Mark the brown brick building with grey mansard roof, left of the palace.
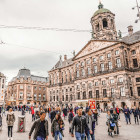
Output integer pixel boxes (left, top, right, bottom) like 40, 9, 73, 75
6, 68, 48, 105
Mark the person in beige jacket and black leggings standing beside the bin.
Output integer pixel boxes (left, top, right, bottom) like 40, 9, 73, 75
6, 108, 15, 140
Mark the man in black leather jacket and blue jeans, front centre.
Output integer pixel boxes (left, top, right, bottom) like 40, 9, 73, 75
71, 108, 89, 140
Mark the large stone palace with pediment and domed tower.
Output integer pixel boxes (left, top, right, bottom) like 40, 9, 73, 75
48, 3, 140, 109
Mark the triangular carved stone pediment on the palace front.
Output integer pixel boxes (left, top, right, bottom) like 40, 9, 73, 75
75, 40, 117, 59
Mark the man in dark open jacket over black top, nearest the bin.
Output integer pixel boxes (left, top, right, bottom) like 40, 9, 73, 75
29, 112, 49, 140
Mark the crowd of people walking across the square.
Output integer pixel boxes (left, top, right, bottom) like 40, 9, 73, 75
0, 104, 140, 140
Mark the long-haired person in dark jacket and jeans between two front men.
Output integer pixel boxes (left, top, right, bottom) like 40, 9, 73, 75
51, 112, 64, 140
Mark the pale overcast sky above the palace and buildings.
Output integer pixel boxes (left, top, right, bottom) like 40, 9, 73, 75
0, 0, 140, 81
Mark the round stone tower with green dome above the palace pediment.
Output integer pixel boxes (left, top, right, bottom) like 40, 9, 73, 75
91, 2, 117, 40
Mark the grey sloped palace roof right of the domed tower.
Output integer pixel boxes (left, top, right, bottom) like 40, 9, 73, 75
122, 31, 140, 44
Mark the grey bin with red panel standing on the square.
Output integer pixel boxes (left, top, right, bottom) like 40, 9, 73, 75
17, 116, 26, 132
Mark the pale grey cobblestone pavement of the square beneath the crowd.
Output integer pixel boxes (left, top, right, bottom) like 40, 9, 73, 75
0, 112, 140, 140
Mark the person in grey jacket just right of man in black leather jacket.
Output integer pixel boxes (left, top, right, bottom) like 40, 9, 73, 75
85, 109, 96, 140
